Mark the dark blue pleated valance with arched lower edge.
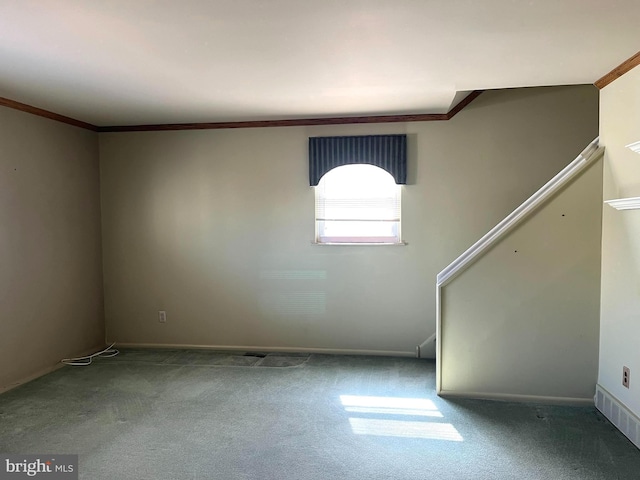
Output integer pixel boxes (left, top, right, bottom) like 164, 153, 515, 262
309, 135, 407, 186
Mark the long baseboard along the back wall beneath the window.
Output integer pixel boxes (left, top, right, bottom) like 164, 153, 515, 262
107, 340, 415, 357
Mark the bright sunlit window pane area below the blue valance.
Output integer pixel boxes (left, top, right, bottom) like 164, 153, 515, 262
315, 164, 402, 244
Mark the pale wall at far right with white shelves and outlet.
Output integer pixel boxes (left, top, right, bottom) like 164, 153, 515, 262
598, 63, 640, 416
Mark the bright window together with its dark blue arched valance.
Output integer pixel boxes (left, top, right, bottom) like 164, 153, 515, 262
309, 135, 407, 244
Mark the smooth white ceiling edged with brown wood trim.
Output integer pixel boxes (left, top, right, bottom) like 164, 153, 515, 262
0, 0, 640, 126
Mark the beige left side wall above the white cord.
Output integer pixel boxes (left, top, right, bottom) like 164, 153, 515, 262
0, 107, 104, 390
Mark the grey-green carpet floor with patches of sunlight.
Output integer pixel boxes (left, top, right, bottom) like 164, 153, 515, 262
0, 350, 640, 480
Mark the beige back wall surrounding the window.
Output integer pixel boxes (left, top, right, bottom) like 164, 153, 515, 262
100, 86, 598, 355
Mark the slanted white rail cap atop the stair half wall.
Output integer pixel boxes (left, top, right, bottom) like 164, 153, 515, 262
437, 137, 604, 286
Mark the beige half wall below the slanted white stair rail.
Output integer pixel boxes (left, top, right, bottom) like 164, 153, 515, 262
441, 160, 602, 402
